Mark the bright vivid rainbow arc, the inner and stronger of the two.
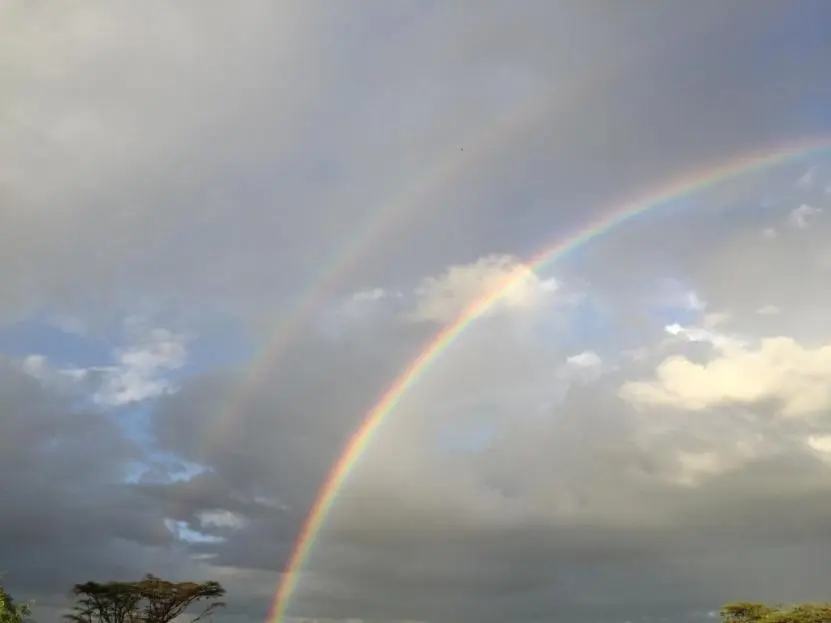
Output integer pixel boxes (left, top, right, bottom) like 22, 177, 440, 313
268, 138, 831, 622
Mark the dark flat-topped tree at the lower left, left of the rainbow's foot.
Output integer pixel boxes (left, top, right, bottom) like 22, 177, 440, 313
66, 574, 225, 623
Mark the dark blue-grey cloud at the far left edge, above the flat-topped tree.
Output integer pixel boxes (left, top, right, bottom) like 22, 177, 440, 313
0, 359, 198, 603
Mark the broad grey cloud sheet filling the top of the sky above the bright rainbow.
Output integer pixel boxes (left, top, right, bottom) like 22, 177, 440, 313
2, 2, 827, 322
